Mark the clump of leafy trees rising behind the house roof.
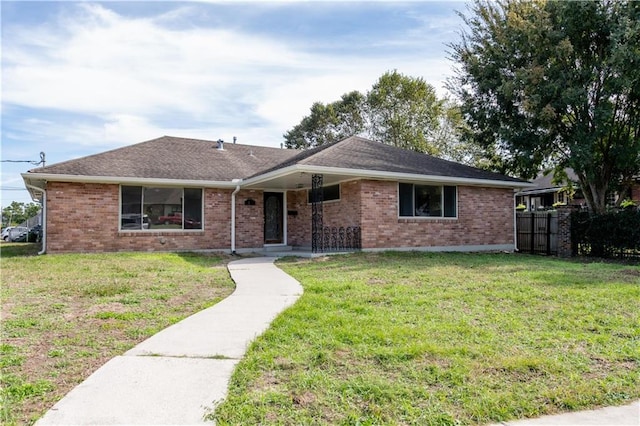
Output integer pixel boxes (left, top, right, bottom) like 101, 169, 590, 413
284, 71, 479, 160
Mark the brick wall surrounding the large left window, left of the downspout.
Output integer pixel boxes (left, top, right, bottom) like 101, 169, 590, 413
46, 182, 235, 253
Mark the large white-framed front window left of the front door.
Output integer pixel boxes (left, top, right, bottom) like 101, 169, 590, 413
120, 186, 202, 231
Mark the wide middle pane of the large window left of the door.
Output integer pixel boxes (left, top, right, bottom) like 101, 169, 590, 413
143, 188, 182, 229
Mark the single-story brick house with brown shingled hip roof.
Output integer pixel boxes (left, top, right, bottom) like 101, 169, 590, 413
22, 136, 530, 253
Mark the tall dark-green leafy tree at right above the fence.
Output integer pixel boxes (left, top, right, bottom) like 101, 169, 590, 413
448, 0, 640, 212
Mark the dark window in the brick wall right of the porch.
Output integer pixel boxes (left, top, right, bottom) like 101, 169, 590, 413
398, 183, 457, 217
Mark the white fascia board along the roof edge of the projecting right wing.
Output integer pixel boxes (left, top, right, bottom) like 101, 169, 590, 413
243, 164, 535, 188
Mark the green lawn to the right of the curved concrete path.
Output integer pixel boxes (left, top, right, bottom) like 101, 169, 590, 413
213, 253, 640, 425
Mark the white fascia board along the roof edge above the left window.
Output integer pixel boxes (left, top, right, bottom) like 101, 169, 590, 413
22, 173, 238, 188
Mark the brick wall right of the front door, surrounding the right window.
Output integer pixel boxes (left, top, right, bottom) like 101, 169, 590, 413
287, 180, 514, 249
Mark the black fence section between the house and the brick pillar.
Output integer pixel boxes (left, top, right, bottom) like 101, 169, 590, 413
516, 211, 558, 255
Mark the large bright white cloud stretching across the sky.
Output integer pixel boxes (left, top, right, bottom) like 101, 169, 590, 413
3, 3, 458, 150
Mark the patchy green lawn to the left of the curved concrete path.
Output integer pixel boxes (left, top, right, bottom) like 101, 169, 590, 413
0, 243, 234, 425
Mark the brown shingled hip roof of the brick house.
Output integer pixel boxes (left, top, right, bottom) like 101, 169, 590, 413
22, 136, 530, 200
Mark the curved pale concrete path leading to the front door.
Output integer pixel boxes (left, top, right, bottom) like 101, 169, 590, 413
36, 257, 302, 425
